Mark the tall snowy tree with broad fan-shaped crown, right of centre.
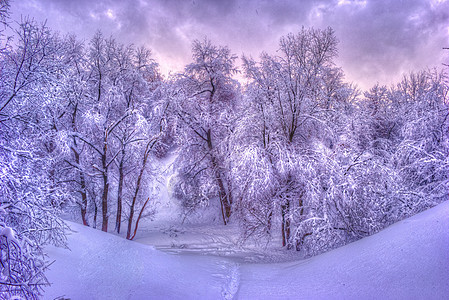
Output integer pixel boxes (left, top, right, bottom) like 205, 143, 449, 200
236, 28, 353, 248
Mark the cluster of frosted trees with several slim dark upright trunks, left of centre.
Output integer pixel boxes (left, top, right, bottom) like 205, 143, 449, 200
62, 32, 160, 232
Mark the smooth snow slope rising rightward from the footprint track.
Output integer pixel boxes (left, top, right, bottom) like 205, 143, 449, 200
237, 202, 449, 299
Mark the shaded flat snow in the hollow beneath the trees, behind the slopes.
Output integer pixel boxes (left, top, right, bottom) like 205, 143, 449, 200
128, 153, 302, 262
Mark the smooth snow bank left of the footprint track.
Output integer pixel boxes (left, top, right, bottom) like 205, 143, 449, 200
44, 223, 238, 300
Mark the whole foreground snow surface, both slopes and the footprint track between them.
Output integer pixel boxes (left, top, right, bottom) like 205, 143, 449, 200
44, 202, 449, 299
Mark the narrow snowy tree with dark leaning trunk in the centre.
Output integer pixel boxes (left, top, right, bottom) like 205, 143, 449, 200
171, 40, 238, 224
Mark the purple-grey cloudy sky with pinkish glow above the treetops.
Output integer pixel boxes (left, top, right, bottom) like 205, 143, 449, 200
11, 0, 449, 89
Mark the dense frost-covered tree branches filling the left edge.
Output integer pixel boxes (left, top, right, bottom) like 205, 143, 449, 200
0, 15, 71, 299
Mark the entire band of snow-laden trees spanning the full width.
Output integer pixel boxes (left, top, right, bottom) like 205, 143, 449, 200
0, 0, 449, 299
